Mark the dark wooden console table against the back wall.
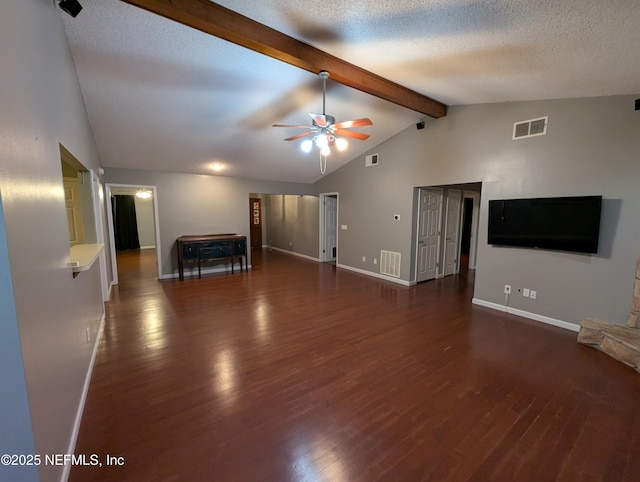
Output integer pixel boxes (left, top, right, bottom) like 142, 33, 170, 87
177, 234, 247, 280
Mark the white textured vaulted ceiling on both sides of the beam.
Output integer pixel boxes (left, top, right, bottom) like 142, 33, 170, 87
61, 0, 640, 182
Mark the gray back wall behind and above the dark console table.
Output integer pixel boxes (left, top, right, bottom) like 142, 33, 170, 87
104, 168, 313, 277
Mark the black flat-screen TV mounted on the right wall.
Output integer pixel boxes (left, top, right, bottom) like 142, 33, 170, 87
488, 196, 602, 253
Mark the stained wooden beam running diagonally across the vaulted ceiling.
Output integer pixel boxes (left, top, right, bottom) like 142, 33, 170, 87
122, 0, 447, 118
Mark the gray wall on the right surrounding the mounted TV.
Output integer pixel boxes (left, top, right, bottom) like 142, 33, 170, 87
314, 96, 640, 324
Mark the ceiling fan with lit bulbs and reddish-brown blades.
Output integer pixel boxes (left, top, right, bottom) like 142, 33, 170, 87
272, 70, 373, 174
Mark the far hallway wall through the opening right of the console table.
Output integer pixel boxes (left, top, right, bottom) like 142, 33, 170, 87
263, 195, 319, 259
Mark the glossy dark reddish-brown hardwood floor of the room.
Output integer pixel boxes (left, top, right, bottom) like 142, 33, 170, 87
70, 251, 640, 482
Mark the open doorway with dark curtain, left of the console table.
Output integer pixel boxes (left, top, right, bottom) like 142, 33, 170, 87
106, 184, 162, 285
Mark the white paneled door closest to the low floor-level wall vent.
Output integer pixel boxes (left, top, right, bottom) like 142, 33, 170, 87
416, 189, 442, 283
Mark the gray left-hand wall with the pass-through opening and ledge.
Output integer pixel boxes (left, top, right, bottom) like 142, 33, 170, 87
0, 0, 103, 481
